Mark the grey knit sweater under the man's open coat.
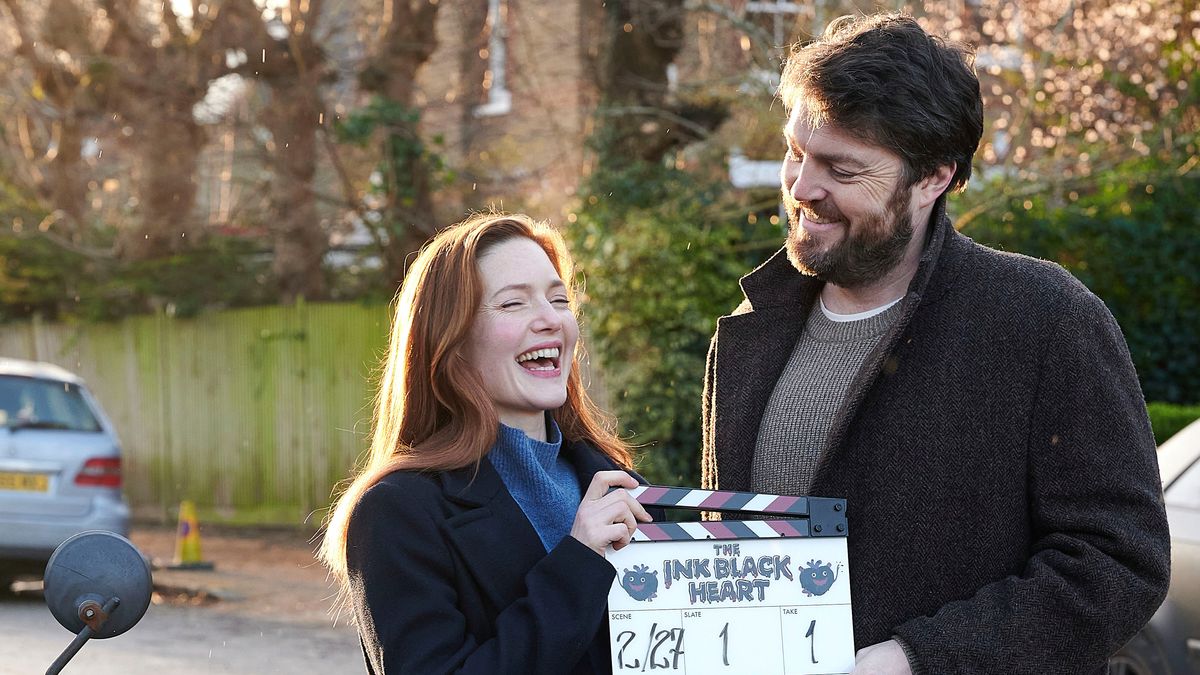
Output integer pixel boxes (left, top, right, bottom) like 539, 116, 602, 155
750, 304, 900, 495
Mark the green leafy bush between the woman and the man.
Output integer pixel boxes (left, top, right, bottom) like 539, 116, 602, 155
568, 162, 782, 485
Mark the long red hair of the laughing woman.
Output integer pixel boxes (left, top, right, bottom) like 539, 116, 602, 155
318, 214, 632, 591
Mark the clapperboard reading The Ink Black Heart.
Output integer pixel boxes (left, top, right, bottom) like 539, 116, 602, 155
607, 485, 854, 675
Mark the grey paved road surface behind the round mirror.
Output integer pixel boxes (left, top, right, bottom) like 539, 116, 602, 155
0, 586, 364, 675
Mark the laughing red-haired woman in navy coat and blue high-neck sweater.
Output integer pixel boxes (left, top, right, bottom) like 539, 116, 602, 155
320, 214, 650, 675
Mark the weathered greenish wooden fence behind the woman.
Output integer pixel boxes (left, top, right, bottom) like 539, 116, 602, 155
0, 304, 389, 525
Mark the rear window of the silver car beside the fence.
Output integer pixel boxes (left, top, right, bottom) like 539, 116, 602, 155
0, 376, 100, 431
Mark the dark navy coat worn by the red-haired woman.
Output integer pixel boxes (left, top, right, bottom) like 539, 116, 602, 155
347, 443, 648, 675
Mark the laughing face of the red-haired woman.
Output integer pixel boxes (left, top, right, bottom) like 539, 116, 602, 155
466, 237, 580, 438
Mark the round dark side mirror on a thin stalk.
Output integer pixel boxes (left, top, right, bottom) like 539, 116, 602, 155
43, 531, 154, 675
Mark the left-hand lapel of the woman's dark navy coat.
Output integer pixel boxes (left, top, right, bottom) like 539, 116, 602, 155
442, 458, 546, 611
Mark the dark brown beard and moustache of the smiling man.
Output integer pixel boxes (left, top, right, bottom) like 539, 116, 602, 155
784, 184, 912, 288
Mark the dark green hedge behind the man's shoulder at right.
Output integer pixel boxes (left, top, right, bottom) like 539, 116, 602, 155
962, 160, 1200, 405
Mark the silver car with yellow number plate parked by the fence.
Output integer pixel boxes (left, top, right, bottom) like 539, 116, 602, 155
0, 358, 130, 581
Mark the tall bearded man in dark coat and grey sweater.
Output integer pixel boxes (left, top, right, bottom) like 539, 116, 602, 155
703, 14, 1170, 675
